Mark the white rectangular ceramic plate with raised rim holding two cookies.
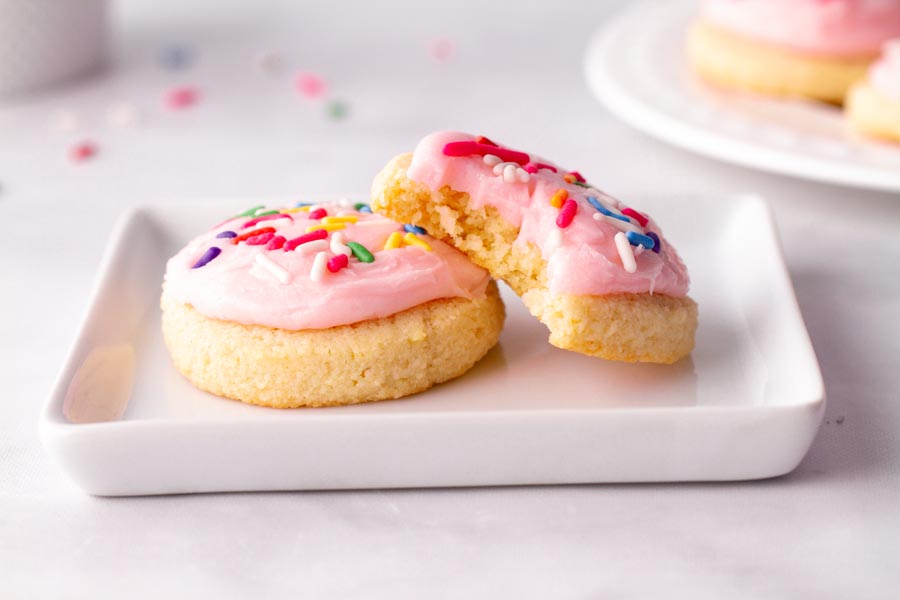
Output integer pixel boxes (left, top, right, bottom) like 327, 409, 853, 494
41, 196, 824, 495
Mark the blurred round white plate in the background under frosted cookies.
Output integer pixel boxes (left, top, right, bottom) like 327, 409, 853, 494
585, 1, 900, 191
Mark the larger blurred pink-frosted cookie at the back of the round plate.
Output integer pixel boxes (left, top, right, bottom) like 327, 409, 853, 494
687, 0, 900, 104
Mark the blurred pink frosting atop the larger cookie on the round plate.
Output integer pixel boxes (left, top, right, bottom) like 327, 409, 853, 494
702, 0, 900, 57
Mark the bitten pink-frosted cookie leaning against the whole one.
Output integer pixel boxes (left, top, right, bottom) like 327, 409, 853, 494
372, 132, 697, 363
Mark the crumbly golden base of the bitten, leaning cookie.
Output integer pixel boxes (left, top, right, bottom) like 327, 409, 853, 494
372, 154, 697, 364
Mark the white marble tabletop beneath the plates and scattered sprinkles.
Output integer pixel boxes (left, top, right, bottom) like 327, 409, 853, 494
0, 0, 900, 599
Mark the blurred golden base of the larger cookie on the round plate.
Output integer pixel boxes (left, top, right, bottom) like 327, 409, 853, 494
687, 20, 875, 104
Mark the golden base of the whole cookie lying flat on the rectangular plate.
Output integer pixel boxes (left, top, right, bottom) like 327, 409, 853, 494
161, 281, 505, 408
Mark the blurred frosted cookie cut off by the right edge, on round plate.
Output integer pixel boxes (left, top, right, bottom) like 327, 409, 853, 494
847, 39, 900, 142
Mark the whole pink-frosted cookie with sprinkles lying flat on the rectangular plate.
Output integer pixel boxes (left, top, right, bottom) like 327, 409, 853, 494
161, 204, 504, 408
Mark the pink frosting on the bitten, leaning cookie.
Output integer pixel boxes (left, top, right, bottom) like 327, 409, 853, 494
407, 132, 689, 297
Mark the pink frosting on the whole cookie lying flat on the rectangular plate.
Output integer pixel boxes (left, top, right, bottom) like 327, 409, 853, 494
158, 205, 490, 330
